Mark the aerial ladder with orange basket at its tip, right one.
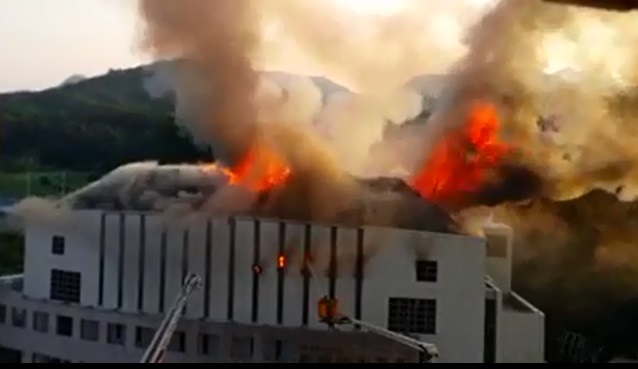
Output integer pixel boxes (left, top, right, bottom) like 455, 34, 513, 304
317, 296, 439, 363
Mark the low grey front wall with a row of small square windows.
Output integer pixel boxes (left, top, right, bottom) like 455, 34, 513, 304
0, 286, 417, 363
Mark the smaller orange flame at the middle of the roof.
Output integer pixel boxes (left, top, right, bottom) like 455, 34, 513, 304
203, 146, 291, 192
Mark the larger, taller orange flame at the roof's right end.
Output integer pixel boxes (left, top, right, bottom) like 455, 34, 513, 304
412, 103, 510, 208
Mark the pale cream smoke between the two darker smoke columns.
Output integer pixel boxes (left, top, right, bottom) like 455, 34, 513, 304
253, 0, 500, 176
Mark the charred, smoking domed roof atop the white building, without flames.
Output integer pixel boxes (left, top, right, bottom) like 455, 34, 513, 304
60, 162, 457, 233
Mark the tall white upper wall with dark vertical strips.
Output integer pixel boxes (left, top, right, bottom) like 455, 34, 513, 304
18, 211, 486, 362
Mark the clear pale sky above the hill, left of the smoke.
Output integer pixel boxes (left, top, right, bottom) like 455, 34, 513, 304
0, 0, 144, 92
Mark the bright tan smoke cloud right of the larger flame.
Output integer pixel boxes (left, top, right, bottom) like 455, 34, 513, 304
442, 1, 638, 201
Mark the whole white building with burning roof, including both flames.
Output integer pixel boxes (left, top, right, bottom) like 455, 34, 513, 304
0, 77, 544, 362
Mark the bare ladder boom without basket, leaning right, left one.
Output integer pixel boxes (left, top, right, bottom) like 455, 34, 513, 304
140, 274, 202, 363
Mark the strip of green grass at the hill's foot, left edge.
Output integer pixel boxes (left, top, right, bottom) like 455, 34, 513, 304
0, 172, 96, 198
